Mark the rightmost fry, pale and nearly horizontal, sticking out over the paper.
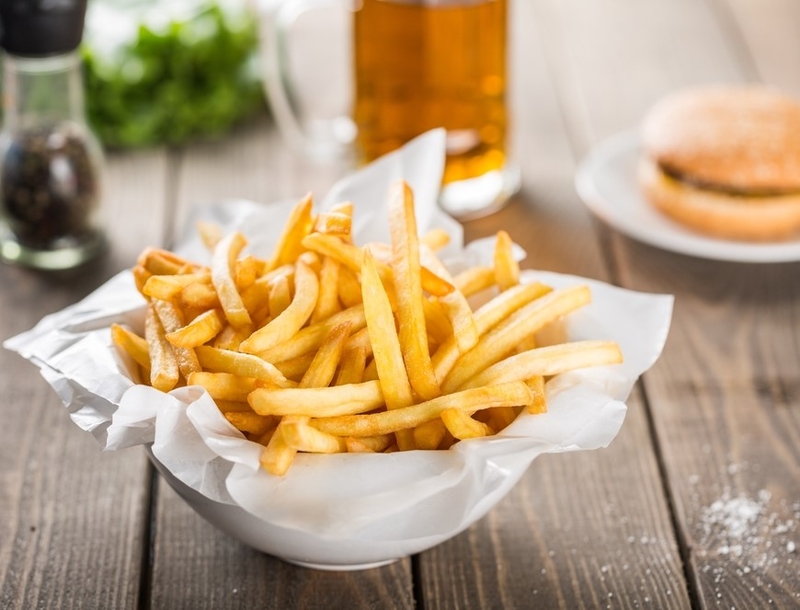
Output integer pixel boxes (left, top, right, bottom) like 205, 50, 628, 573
459, 340, 622, 388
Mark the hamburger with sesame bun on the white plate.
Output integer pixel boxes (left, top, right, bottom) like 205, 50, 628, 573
639, 85, 800, 242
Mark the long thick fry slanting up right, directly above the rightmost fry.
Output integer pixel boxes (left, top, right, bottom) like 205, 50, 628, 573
442, 285, 591, 392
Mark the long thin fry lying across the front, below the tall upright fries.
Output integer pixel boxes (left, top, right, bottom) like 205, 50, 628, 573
311, 381, 531, 437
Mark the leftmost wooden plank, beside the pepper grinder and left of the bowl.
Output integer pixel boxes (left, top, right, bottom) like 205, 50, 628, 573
0, 146, 170, 608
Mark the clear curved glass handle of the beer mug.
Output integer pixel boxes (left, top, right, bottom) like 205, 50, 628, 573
260, 0, 355, 162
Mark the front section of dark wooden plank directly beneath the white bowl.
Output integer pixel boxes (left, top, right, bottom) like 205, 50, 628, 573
151, 479, 414, 610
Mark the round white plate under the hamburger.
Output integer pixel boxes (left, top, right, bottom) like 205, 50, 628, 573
575, 131, 800, 263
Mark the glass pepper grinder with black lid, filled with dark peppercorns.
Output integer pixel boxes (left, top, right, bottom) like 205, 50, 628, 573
0, 0, 104, 270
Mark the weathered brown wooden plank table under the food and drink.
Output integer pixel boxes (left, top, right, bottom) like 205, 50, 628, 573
0, 0, 800, 610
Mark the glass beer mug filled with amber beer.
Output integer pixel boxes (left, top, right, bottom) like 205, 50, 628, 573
261, 0, 520, 219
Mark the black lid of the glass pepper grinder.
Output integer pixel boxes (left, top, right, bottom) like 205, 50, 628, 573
0, 0, 87, 57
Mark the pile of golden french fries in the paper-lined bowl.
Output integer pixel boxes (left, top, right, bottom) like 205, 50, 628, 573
112, 182, 622, 475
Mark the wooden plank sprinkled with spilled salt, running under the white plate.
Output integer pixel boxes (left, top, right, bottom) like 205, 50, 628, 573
536, 2, 800, 607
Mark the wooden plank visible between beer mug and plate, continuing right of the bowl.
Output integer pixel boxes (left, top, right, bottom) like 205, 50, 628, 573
419, 2, 689, 609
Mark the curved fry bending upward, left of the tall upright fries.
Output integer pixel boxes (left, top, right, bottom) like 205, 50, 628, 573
239, 261, 319, 354
